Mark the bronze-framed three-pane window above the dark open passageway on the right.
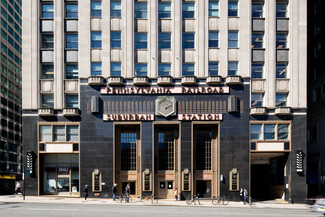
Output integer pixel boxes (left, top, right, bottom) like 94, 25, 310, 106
251, 123, 290, 141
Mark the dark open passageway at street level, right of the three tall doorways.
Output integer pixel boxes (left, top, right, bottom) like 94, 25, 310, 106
251, 153, 287, 200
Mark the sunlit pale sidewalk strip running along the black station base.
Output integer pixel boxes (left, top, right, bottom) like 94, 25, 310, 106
0, 195, 310, 209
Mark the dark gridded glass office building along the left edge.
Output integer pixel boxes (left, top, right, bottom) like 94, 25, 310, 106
0, 0, 22, 194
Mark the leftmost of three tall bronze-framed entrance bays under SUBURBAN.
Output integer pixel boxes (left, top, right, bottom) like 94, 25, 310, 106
115, 125, 141, 197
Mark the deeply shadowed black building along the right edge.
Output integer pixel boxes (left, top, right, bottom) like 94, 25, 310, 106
307, 0, 325, 197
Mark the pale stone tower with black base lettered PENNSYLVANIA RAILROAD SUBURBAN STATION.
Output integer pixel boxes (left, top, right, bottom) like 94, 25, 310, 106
23, 0, 307, 201
